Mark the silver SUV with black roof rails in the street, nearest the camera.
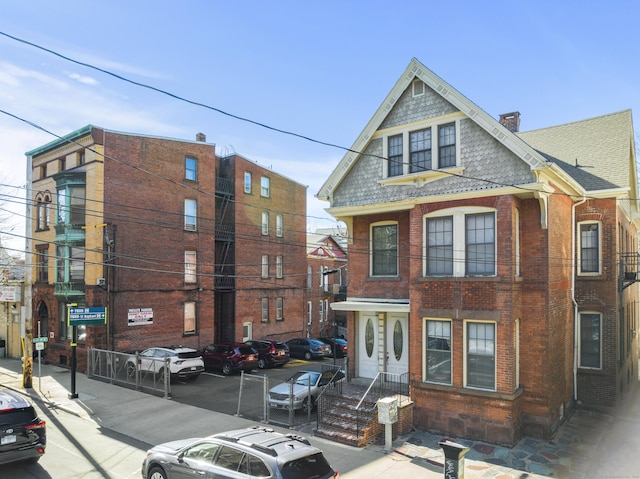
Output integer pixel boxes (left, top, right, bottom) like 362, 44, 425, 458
142, 426, 340, 479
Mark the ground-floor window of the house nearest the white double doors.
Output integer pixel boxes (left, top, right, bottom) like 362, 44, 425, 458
423, 319, 452, 385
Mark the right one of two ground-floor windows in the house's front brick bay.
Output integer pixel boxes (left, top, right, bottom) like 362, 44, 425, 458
464, 321, 496, 391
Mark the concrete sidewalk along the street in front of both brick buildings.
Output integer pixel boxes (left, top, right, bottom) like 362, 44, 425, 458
0, 358, 640, 479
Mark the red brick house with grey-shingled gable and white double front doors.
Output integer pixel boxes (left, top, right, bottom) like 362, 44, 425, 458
318, 59, 639, 445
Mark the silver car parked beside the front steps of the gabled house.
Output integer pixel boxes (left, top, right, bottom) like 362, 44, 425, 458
269, 370, 344, 409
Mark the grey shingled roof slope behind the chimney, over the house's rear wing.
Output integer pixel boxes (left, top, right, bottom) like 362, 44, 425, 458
518, 110, 637, 198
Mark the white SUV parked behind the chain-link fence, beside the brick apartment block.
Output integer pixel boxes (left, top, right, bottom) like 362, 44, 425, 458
127, 346, 204, 380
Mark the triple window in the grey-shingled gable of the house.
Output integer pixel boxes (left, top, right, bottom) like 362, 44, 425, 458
382, 119, 460, 178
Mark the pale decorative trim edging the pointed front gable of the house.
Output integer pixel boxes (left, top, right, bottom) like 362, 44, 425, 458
316, 58, 547, 200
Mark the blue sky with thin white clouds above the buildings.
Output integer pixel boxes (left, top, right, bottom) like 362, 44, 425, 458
0, 0, 640, 255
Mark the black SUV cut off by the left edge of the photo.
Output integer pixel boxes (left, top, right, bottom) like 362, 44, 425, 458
0, 389, 47, 464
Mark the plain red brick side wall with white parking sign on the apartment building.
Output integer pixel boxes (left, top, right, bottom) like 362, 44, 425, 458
102, 132, 215, 351
